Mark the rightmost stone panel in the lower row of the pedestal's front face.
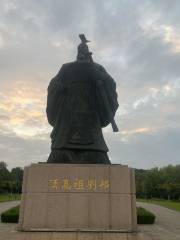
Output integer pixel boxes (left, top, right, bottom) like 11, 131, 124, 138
110, 194, 132, 230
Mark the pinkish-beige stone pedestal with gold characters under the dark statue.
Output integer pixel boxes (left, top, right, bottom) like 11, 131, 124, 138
19, 163, 137, 232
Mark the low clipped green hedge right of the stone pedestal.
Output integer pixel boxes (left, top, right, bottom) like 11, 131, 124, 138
137, 207, 156, 224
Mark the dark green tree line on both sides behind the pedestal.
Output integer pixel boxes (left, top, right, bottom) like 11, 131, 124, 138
0, 162, 180, 200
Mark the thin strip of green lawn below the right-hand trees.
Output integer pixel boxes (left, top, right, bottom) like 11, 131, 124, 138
137, 199, 180, 212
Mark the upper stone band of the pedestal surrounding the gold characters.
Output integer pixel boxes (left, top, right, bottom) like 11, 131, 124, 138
23, 164, 135, 193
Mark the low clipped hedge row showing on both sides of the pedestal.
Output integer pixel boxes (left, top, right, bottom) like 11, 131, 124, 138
1, 206, 155, 224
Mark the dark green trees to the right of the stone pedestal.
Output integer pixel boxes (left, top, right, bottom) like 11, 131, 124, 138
135, 165, 180, 200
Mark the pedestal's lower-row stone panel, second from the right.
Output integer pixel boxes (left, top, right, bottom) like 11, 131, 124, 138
89, 194, 109, 229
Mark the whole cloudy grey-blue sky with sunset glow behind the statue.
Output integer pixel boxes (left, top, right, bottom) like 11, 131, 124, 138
0, 0, 180, 168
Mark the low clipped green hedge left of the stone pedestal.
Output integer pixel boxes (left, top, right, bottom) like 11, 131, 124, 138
1, 206, 19, 223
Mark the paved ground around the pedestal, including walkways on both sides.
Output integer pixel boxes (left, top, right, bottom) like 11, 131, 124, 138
0, 201, 180, 240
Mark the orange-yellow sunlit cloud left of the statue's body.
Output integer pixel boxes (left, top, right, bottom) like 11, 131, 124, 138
0, 83, 50, 138
